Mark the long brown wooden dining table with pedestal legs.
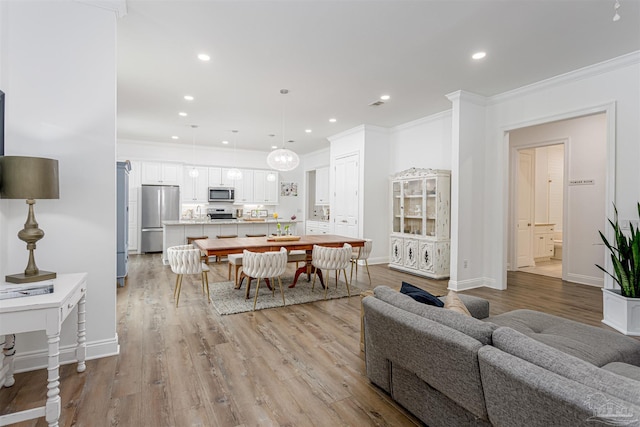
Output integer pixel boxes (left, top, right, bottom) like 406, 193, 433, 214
193, 234, 365, 288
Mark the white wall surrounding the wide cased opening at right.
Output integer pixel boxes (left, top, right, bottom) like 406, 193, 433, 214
484, 52, 640, 287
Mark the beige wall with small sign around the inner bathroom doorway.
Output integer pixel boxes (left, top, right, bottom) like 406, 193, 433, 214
509, 114, 607, 286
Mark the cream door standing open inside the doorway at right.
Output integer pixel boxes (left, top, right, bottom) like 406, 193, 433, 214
516, 150, 533, 268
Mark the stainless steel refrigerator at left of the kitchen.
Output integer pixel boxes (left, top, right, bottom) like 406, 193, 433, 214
140, 185, 180, 253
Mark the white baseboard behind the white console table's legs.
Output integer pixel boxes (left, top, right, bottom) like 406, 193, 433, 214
13, 334, 120, 373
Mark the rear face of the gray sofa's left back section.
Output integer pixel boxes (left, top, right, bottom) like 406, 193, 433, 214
362, 296, 486, 419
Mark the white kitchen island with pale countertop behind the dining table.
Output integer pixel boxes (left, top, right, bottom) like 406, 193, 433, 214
162, 219, 301, 264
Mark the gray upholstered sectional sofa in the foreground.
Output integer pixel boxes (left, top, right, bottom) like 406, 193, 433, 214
362, 286, 640, 427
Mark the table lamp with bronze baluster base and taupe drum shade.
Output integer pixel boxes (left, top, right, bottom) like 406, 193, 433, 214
0, 156, 59, 283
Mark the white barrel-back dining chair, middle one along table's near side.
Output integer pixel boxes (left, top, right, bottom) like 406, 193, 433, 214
242, 248, 287, 311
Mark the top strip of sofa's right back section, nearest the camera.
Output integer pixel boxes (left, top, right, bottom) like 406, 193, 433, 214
493, 327, 640, 405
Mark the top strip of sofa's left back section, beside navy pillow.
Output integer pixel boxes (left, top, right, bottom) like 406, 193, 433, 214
373, 286, 497, 344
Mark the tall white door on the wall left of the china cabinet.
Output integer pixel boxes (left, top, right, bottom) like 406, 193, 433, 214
331, 154, 360, 237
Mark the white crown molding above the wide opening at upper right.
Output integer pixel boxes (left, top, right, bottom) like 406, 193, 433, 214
487, 50, 640, 105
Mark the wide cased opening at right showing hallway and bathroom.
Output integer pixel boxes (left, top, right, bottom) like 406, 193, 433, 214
508, 110, 611, 286
